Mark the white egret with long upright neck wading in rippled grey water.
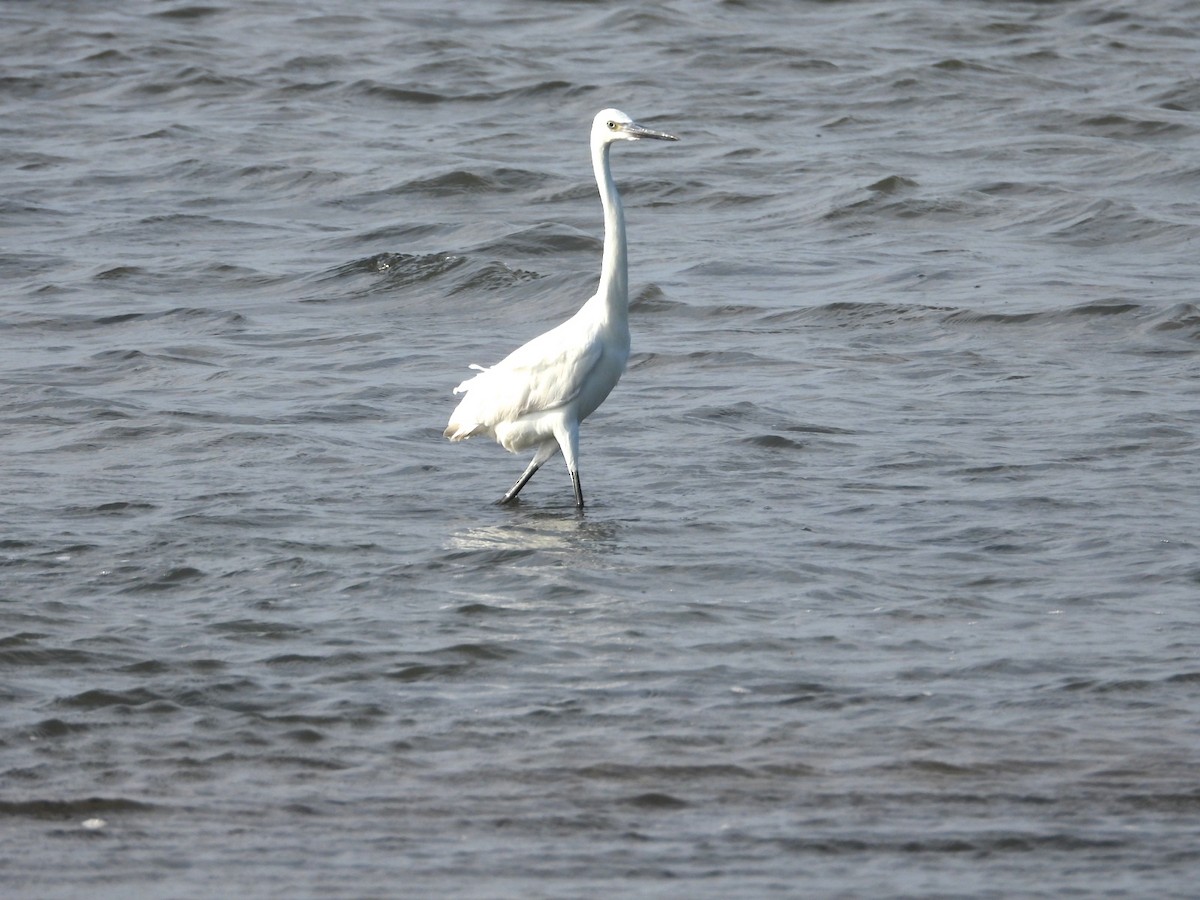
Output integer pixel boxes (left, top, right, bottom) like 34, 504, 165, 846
445, 109, 678, 508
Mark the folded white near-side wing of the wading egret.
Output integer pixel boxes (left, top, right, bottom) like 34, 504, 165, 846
445, 323, 604, 440
